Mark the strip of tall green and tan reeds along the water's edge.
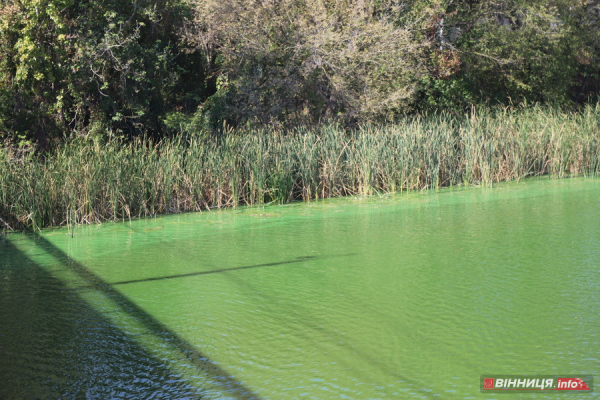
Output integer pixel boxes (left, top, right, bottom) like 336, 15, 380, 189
0, 106, 600, 229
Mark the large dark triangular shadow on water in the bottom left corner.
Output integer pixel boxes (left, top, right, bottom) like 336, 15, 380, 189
0, 238, 202, 400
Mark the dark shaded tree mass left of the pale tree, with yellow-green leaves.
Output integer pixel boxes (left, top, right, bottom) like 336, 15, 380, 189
0, 0, 204, 146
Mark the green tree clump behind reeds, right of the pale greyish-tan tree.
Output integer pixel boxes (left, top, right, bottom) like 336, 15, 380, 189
413, 0, 600, 107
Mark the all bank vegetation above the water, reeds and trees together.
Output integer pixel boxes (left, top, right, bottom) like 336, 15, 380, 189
0, 0, 600, 231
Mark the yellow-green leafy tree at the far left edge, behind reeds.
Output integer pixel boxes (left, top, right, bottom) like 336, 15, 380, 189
0, 0, 72, 142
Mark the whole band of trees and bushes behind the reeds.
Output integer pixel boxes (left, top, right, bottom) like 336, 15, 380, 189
0, 0, 600, 144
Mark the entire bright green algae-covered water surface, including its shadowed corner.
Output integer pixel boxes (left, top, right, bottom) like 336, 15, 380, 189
0, 178, 600, 399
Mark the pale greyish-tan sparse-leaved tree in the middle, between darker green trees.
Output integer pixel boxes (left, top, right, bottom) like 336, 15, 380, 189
185, 0, 425, 126
